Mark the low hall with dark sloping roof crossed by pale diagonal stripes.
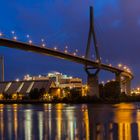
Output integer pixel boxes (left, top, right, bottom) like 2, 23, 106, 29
0, 80, 55, 99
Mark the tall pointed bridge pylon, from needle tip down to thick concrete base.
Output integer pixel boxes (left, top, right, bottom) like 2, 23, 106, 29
85, 7, 101, 97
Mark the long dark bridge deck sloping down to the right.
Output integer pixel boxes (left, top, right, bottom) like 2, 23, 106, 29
0, 38, 133, 79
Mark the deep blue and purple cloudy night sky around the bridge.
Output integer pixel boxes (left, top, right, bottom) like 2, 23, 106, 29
0, 0, 140, 87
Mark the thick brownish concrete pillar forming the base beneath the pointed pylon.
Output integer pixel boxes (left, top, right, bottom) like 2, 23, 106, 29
87, 74, 99, 97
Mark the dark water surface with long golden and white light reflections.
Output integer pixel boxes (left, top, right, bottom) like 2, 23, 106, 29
0, 103, 140, 140
